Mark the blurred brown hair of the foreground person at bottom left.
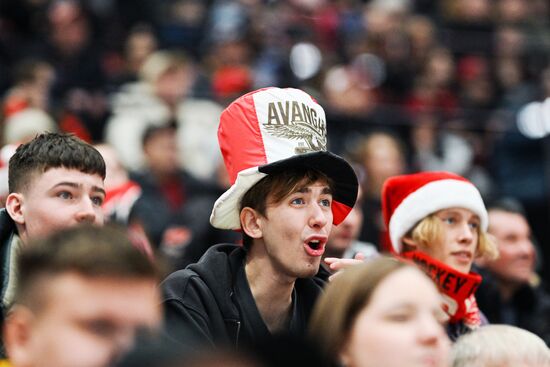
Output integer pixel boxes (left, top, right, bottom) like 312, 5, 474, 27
15, 224, 163, 309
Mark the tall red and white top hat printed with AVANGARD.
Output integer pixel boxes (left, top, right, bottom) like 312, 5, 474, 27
210, 88, 358, 229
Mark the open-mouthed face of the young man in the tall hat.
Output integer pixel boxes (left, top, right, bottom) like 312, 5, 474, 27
253, 181, 332, 278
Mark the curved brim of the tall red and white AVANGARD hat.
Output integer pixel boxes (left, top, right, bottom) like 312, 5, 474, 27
210, 151, 358, 229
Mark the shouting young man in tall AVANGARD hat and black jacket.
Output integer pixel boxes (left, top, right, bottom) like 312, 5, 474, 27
162, 88, 357, 346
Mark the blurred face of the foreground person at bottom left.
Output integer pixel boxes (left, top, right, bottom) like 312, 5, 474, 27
8, 273, 161, 367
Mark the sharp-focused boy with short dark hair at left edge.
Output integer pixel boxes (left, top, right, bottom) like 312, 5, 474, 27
0, 133, 105, 324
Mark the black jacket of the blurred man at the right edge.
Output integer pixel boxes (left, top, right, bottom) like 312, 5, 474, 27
476, 271, 550, 346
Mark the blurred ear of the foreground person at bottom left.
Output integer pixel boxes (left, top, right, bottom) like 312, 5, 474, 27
3, 306, 34, 366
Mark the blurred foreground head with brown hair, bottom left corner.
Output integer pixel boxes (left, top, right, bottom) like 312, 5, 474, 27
4, 226, 161, 367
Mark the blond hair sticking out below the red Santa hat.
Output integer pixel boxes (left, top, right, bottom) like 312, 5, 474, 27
403, 213, 498, 260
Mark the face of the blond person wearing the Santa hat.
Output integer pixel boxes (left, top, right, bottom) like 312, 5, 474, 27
418, 208, 480, 273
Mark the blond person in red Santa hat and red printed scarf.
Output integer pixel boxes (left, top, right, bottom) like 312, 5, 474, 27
382, 172, 498, 339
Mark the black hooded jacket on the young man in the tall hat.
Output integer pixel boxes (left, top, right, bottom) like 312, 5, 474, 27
161, 244, 324, 347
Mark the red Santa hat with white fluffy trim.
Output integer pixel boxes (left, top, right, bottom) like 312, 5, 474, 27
382, 172, 488, 253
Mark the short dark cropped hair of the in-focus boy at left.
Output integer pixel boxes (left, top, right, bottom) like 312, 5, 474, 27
8, 133, 105, 193
